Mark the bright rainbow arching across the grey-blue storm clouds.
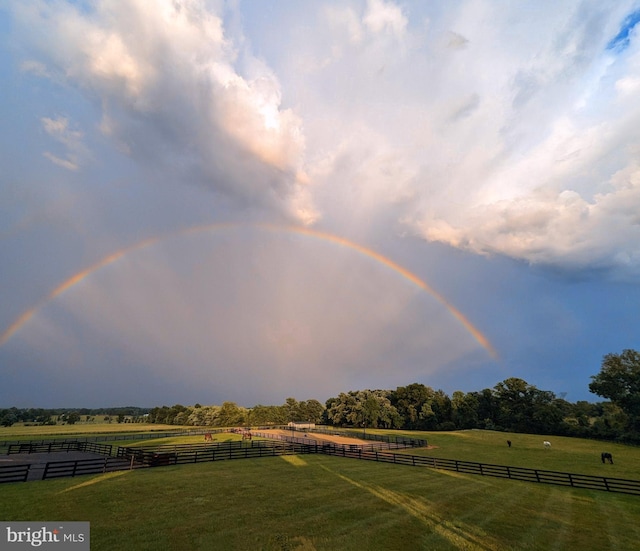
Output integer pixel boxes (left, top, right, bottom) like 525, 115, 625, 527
0, 223, 498, 358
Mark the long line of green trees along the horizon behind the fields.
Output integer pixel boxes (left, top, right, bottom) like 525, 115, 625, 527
5, 349, 640, 443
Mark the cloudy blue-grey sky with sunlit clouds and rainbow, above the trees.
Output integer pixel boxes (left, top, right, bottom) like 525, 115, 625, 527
0, 0, 640, 407
